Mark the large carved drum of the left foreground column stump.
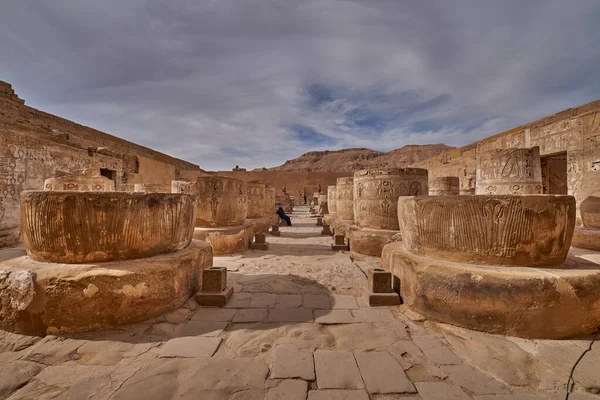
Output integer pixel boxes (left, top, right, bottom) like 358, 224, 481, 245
21, 191, 194, 264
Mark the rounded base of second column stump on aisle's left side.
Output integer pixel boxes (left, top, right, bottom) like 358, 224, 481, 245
194, 223, 254, 255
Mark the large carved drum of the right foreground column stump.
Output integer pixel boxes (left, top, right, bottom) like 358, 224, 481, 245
398, 195, 575, 267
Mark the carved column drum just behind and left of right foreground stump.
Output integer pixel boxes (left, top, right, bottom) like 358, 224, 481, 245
354, 168, 428, 230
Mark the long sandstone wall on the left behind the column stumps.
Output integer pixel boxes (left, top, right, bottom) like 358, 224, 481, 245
0, 81, 200, 247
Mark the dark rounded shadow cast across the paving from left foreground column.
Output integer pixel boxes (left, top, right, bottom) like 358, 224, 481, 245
61, 273, 340, 344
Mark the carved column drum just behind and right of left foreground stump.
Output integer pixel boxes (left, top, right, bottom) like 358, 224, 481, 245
171, 176, 248, 228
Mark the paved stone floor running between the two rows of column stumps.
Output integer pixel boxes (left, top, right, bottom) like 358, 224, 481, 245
0, 207, 600, 400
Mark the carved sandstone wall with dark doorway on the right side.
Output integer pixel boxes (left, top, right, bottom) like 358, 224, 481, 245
413, 100, 600, 224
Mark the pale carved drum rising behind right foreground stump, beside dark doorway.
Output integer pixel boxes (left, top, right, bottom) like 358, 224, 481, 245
475, 147, 543, 194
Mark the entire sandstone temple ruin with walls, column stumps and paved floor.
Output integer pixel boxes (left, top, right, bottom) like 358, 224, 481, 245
0, 82, 600, 400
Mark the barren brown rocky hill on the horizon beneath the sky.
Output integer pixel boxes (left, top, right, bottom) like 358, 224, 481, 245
269, 144, 452, 172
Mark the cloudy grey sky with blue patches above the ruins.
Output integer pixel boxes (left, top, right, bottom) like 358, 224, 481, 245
0, 0, 600, 170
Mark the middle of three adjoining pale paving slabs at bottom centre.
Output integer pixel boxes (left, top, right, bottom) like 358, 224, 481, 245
314, 350, 365, 389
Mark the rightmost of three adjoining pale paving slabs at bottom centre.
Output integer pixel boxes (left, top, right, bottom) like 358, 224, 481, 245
354, 351, 417, 394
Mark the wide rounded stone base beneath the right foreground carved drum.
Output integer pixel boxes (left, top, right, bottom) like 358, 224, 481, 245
381, 242, 600, 339
